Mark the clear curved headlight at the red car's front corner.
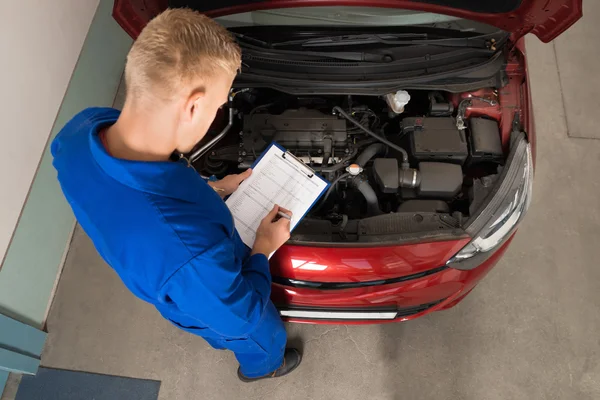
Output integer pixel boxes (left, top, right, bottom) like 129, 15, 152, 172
446, 134, 533, 270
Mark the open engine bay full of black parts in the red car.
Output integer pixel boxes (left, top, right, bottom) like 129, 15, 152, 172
194, 89, 506, 244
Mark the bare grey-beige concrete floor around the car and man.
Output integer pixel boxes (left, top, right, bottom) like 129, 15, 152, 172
8, 10, 600, 400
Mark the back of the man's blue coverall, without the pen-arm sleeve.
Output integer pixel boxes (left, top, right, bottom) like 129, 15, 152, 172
52, 108, 247, 325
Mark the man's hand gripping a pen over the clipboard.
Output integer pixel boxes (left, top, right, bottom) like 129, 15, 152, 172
252, 205, 292, 257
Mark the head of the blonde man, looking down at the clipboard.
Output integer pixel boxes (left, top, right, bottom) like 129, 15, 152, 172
125, 9, 241, 153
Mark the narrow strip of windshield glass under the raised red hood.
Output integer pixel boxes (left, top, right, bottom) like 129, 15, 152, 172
216, 6, 498, 33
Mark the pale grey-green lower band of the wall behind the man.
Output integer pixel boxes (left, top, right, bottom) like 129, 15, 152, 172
0, 0, 132, 327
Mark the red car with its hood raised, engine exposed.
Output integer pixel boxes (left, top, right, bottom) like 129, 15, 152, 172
114, 0, 582, 324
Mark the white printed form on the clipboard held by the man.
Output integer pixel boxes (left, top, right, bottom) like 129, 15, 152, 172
225, 143, 329, 248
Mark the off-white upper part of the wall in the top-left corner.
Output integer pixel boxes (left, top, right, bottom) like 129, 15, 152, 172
0, 0, 98, 260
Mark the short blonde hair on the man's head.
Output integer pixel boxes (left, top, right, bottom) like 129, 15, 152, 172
125, 8, 241, 99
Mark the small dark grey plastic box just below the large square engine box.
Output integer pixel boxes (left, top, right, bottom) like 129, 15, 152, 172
418, 162, 463, 199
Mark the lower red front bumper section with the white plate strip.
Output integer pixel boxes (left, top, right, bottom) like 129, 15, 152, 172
271, 237, 512, 324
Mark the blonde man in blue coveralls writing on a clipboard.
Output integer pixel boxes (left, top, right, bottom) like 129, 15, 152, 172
52, 9, 301, 382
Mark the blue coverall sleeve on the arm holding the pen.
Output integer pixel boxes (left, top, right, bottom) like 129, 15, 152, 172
164, 238, 271, 338
